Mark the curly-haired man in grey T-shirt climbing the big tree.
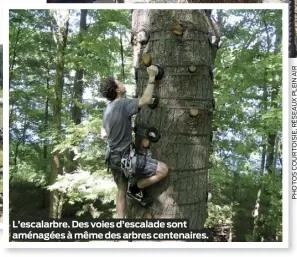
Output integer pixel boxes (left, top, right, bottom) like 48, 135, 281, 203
100, 65, 168, 218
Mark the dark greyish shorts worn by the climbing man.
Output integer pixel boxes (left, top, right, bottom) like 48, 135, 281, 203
111, 153, 158, 184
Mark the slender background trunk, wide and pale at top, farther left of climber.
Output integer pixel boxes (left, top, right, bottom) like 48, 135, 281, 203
49, 10, 70, 218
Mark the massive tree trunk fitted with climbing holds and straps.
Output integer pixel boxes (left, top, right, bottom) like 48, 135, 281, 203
128, 10, 217, 229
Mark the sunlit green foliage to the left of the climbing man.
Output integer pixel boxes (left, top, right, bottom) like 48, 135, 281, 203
9, 10, 132, 217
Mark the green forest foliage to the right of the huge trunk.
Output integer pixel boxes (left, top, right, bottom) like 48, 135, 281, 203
206, 10, 282, 241
